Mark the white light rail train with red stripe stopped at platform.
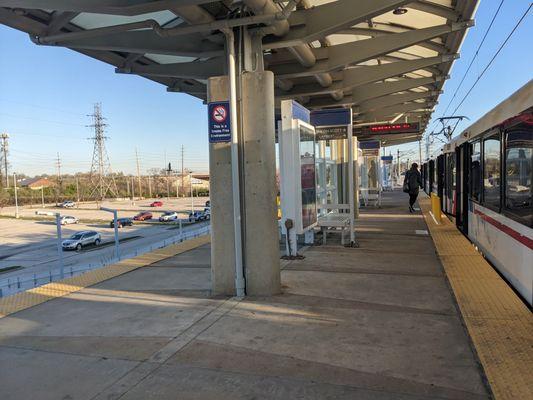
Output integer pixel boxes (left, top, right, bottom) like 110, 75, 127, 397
422, 81, 533, 307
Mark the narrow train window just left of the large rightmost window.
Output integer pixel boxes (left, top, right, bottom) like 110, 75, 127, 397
483, 134, 501, 211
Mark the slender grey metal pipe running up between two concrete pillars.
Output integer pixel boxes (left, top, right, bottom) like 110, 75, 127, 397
224, 29, 245, 297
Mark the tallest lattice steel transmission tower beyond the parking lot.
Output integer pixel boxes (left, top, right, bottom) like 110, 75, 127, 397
89, 103, 118, 200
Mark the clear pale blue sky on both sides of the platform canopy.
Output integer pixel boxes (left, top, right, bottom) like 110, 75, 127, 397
0, 0, 533, 175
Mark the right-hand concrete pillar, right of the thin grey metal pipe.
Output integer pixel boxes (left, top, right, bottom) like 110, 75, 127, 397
242, 71, 281, 296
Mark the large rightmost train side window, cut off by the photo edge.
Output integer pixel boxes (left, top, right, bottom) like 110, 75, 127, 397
505, 124, 533, 227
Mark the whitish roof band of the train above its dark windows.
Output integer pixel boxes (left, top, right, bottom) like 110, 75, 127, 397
442, 80, 533, 153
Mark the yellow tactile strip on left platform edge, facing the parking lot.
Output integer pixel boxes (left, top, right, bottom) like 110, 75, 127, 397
0, 235, 210, 318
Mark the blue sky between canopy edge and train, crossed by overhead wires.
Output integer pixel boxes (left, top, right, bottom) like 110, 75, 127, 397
386, 0, 533, 161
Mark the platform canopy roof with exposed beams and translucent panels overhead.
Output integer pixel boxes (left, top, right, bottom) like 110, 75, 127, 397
0, 0, 479, 144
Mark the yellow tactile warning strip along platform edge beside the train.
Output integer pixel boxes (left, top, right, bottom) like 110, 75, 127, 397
420, 199, 533, 400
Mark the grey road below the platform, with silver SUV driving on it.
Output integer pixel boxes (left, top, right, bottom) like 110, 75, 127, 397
0, 219, 209, 295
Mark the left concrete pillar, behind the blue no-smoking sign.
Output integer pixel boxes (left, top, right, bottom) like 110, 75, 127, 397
207, 76, 235, 295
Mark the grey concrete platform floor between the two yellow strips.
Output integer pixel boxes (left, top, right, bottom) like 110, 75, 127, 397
0, 193, 490, 400
